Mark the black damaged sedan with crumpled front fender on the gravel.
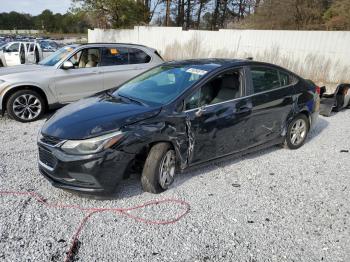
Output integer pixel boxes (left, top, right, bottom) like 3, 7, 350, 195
38, 59, 319, 194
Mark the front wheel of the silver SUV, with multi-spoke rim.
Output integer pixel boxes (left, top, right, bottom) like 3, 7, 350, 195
6, 90, 46, 123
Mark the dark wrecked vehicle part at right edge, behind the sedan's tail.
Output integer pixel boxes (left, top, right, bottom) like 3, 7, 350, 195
320, 84, 350, 116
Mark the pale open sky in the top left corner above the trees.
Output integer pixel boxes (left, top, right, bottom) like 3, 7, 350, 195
0, 0, 71, 15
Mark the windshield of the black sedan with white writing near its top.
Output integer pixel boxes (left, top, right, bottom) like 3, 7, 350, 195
113, 64, 219, 105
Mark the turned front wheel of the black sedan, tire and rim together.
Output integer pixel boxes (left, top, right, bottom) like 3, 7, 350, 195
141, 143, 176, 194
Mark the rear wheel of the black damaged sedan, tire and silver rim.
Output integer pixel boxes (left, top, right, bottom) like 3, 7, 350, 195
284, 114, 310, 150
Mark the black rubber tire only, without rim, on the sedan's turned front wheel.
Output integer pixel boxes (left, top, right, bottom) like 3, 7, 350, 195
141, 143, 176, 194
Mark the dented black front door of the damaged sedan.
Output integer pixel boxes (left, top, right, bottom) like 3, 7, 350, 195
186, 98, 252, 164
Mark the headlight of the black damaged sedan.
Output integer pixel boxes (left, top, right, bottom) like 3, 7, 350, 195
61, 131, 123, 155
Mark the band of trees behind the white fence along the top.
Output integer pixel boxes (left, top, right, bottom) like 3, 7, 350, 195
0, 0, 350, 33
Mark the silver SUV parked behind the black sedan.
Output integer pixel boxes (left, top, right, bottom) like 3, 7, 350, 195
0, 44, 163, 122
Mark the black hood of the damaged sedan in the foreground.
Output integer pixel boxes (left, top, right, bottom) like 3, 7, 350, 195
41, 94, 161, 140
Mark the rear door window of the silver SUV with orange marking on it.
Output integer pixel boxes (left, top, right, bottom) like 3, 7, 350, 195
101, 47, 129, 66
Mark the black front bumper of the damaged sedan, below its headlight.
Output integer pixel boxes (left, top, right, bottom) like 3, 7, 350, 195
38, 143, 134, 194
